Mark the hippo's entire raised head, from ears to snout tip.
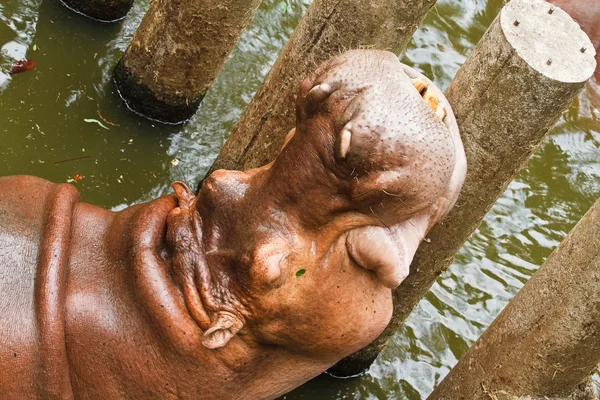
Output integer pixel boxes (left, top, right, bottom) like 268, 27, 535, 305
168, 50, 466, 367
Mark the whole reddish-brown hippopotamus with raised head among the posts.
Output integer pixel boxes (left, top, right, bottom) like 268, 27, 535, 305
0, 50, 466, 400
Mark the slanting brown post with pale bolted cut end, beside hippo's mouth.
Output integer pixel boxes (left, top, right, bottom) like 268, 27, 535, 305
332, 0, 595, 376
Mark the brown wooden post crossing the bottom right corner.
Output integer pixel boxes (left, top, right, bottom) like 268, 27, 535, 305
429, 200, 600, 400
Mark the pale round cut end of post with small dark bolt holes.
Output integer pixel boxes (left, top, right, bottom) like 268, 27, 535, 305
500, 0, 596, 83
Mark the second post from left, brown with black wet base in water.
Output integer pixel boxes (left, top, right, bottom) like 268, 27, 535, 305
114, 0, 261, 123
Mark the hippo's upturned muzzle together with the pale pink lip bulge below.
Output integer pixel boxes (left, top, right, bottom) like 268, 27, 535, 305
275, 50, 466, 288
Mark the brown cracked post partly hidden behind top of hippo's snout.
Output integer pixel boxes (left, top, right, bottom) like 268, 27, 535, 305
211, 0, 435, 170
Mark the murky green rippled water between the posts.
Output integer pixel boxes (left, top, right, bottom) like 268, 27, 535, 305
0, 0, 600, 400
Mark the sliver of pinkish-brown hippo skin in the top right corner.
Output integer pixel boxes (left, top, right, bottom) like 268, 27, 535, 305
548, 0, 600, 101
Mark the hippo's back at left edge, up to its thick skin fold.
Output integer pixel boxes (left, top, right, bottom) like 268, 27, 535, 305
0, 176, 79, 399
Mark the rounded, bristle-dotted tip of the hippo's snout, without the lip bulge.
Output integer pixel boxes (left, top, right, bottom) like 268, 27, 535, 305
297, 50, 462, 225
